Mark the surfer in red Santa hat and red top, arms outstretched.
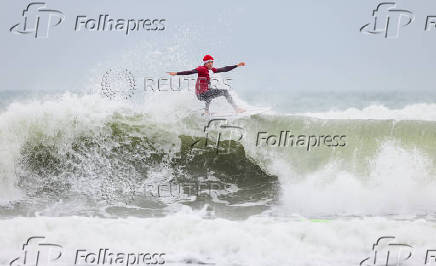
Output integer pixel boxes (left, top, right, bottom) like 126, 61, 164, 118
168, 55, 245, 114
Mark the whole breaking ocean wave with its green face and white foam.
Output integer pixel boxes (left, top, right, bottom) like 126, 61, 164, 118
0, 93, 436, 216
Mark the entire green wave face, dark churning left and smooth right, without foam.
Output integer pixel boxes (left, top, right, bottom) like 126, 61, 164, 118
10, 114, 436, 218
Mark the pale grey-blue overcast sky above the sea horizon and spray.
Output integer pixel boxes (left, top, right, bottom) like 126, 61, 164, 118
0, 0, 436, 95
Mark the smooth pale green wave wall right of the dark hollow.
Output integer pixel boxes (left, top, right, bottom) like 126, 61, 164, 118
238, 115, 436, 176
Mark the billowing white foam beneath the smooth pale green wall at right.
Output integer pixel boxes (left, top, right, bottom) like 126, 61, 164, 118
271, 142, 436, 216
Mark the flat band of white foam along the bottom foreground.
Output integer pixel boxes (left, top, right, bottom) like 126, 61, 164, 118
0, 212, 436, 266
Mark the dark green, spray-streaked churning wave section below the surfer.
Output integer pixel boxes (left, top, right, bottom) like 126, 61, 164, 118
17, 115, 277, 213
